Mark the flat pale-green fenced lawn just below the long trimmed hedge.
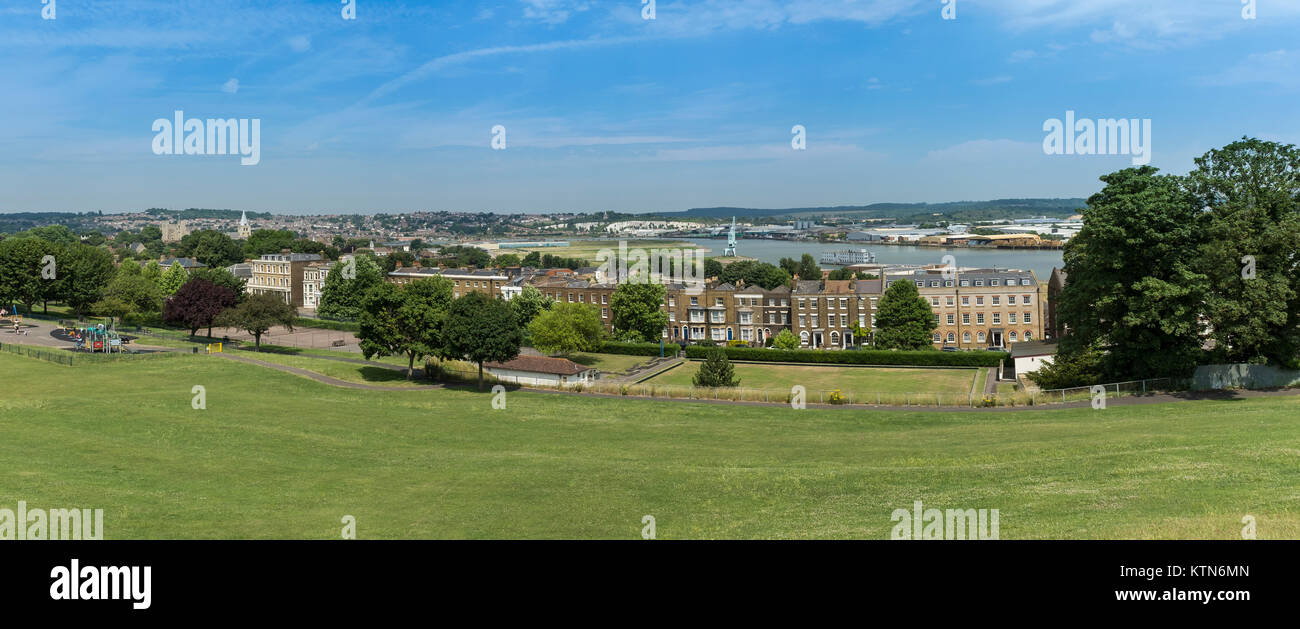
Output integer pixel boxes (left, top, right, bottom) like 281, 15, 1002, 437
646, 361, 976, 399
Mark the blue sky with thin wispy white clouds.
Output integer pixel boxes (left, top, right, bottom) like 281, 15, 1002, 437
0, 0, 1300, 213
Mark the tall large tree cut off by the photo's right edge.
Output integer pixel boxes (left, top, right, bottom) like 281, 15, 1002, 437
1190, 138, 1300, 366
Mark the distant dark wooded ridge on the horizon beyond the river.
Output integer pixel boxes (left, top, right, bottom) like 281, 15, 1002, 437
654, 199, 1086, 221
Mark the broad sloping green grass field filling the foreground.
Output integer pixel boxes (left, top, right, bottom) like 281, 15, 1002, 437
0, 353, 1300, 539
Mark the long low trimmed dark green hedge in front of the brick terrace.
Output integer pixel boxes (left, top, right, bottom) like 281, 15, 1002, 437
686, 346, 1009, 366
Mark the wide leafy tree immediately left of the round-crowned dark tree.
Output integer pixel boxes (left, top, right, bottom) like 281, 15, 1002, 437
358, 277, 452, 379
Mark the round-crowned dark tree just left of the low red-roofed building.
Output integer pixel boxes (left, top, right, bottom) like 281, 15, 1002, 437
439, 292, 524, 390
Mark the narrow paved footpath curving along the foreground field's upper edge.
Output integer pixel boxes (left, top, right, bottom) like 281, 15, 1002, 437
217, 353, 1300, 413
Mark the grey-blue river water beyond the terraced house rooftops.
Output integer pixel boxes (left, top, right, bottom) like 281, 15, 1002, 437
686, 238, 1065, 282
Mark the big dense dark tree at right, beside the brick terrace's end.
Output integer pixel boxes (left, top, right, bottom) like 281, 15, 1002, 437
1057, 166, 1206, 379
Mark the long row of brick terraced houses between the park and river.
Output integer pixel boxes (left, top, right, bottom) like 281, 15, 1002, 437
389, 262, 1045, 350
